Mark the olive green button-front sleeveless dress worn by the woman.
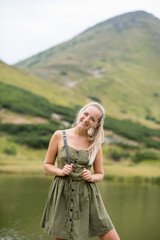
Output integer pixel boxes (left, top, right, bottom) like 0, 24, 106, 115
40, 132, 114, 240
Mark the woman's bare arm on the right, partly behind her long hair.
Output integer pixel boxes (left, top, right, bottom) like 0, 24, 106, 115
82, 147, 104, 182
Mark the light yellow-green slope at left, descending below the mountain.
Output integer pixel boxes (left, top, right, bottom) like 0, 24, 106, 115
0, 61, 84, 105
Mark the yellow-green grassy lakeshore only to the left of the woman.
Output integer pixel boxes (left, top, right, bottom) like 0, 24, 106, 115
0, 136, 46, 174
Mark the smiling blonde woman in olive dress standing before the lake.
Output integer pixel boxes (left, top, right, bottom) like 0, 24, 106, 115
40, 102, 119, 240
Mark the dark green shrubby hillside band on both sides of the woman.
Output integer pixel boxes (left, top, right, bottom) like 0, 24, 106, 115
0, 72, 160, 156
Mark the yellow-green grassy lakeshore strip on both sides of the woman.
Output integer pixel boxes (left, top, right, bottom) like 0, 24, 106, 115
0, 138, 160, 183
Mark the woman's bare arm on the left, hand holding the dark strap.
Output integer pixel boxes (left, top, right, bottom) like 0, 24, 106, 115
44, 131, 72, 176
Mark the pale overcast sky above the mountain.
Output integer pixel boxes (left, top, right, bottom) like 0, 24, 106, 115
0, 0, 160, 65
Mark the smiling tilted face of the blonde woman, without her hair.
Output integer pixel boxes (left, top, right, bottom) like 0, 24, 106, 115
78, 106, 102, 130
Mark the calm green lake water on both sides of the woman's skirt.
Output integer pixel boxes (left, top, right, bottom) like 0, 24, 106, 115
0, 175, 160, 240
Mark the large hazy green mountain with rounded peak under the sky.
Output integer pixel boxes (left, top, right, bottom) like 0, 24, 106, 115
15, 11, 160, 124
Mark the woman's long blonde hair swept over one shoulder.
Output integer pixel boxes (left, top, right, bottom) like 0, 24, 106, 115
72, 102, 105, 165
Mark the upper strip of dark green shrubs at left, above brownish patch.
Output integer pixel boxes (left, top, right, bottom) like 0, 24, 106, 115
0, 83, 75, 119
